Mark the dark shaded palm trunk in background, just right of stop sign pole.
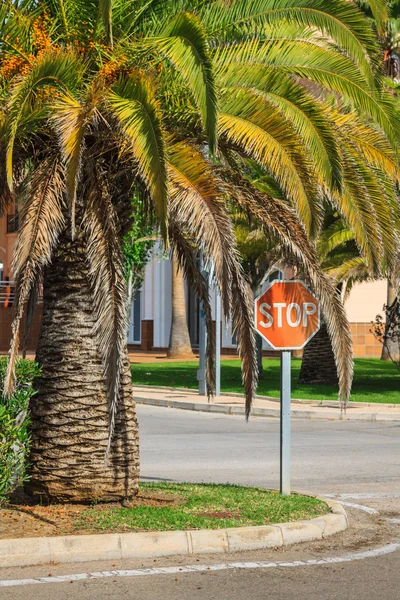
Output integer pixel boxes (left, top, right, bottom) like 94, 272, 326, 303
299, 323, 338, 385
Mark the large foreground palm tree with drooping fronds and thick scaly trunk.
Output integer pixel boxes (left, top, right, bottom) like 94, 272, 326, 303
0, 0, 399, 501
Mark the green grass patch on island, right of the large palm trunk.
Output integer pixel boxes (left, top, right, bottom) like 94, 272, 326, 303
74, 483, 328, 531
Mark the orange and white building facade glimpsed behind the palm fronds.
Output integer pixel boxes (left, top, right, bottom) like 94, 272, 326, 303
0, 211, 387, 357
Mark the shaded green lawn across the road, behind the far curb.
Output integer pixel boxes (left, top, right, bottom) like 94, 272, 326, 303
131, 358, 400, 404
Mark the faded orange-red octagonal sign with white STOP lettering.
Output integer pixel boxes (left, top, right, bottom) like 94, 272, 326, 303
254, 281, 320, 350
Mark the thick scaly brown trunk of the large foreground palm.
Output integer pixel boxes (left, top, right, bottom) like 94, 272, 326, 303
27, 232, 139, 502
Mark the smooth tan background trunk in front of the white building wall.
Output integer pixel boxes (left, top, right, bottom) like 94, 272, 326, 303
168, 257, 194, 359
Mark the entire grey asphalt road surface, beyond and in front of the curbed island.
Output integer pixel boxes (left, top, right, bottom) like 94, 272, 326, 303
0, 406, 400, 600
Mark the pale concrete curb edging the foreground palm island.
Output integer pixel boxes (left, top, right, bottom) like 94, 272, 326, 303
0, 498, 348, 567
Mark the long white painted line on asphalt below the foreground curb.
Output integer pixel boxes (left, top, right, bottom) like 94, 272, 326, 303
0, 542, 400, 587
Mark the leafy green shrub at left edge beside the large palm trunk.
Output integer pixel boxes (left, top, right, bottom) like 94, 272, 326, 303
0, 357, 40, 504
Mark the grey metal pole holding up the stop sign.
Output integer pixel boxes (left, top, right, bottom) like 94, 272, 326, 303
280, 350, 291, 496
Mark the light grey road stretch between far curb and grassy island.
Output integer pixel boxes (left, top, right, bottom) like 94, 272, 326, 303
139, 406, 400, 493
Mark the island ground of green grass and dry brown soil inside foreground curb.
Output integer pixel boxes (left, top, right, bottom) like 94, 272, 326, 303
0, 482, 329, 539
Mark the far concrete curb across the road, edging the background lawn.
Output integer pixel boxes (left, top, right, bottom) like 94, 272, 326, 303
134, 392, 400, 421
